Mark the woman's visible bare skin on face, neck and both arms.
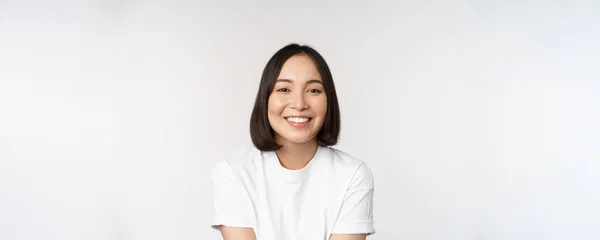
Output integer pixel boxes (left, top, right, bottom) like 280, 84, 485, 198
221, 54, 367, 240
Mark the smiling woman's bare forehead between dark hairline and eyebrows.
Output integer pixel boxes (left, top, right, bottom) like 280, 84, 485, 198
277, 54, 321, 80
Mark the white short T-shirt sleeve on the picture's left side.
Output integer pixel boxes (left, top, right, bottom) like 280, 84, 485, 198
211, 161, 256, 230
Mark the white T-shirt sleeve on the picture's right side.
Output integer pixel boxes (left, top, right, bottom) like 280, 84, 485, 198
332, 164, 375, 235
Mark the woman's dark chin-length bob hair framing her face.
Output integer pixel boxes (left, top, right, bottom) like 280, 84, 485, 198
250, 43, 340, 151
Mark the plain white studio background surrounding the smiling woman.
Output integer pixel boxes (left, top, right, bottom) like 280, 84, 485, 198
0, 0, 600, 240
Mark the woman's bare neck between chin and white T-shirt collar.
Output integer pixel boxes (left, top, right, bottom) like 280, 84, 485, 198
275, 140, 318, 170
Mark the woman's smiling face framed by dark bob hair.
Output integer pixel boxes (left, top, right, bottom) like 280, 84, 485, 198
268, 54, 327, 145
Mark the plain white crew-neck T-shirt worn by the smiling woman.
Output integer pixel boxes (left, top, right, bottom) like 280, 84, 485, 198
212, 146, 375, 240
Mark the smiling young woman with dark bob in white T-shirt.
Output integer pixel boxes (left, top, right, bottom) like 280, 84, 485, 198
212, 44, 375, 240
